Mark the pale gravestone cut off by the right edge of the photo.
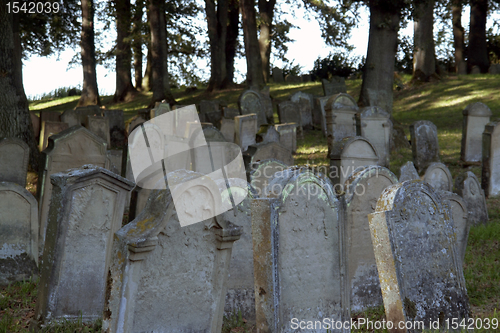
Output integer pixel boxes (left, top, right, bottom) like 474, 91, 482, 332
481, 121, 500, 197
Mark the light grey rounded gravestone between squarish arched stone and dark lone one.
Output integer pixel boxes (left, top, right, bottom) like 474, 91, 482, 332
360, 106, 392, 167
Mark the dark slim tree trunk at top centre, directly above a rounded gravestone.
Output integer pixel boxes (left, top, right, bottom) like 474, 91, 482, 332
240, 0, 265, 90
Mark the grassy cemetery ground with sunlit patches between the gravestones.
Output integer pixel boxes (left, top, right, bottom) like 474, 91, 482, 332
0, 74, 500, 333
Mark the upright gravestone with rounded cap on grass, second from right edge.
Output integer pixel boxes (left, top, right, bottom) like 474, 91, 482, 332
460, 102, 492, 163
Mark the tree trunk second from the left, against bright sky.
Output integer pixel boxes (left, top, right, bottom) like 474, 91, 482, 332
78, 0, 101, 106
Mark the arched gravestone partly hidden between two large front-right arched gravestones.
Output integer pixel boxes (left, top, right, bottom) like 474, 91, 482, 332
344, 166, 398, 312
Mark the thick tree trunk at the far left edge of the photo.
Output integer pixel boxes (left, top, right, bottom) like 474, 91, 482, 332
0, 5, 39, 171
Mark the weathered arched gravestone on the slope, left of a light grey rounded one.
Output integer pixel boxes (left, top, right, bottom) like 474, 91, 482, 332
325, 93, 361, 142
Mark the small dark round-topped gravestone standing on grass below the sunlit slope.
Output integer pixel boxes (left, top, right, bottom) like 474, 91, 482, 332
410, 120, 439, 172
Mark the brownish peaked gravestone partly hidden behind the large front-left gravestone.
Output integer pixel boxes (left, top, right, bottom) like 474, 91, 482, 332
37, 126, 109, 249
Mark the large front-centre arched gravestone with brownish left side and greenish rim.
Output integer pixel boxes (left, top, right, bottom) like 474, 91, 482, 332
252, 168, 350, 333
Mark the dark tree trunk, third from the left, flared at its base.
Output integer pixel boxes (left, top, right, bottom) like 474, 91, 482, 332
113, 0, 136, 102
